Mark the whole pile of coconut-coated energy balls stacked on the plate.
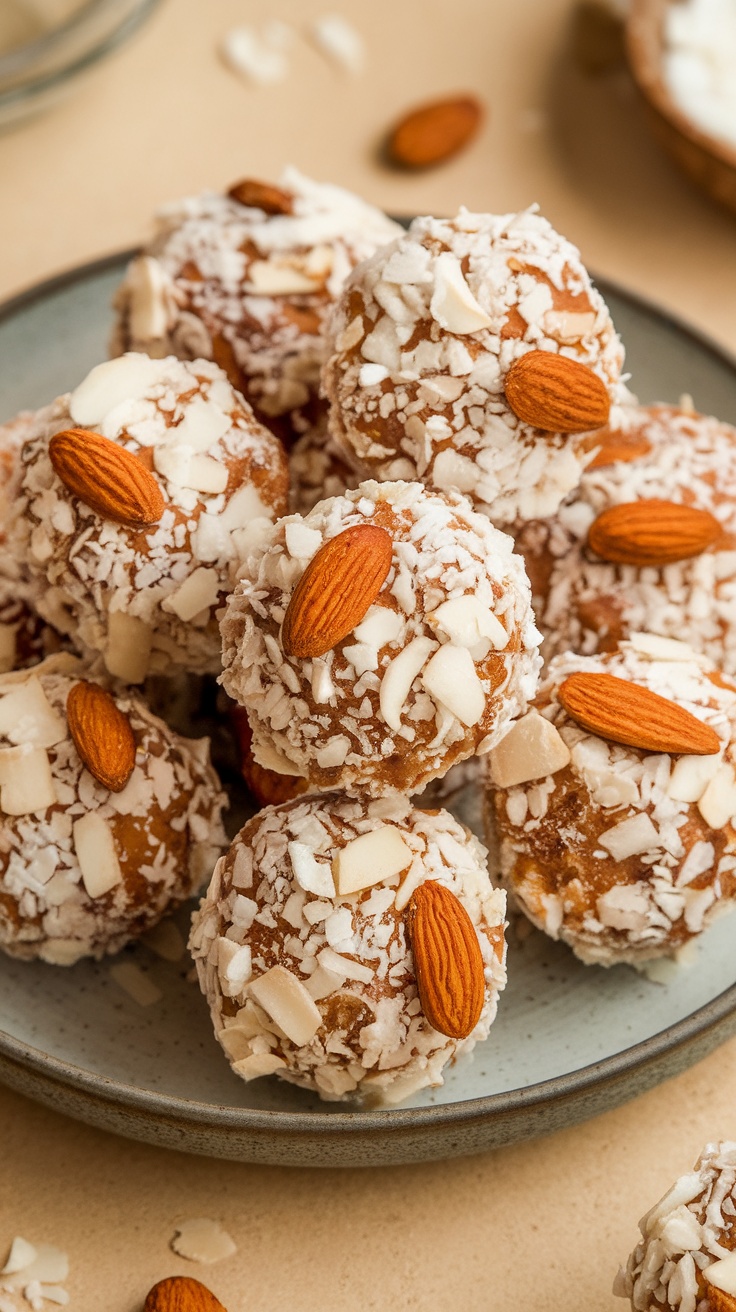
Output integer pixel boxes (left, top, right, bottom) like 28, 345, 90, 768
0, 171, 736, 1102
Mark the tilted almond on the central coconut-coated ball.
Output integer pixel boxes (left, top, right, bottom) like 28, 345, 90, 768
281, 523, 394, 660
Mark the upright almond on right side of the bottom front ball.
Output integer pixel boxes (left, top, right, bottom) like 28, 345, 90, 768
408, 879, 485, 1039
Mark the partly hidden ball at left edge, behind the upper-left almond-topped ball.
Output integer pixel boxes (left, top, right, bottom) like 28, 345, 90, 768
0, 411, 59, 673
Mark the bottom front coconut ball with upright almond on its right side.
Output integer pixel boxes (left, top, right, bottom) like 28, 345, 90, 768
189, 795, 505, 1102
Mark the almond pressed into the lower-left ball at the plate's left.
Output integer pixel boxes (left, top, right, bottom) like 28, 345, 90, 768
67, 681, 135, 792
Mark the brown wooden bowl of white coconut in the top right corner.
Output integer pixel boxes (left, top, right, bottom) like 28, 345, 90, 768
626, 0, 736, 211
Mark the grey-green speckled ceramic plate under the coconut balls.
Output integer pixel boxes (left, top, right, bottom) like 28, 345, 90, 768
0, 256, 736, 1166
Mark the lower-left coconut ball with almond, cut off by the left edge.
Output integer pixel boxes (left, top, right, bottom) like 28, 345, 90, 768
0, 656, 226, 966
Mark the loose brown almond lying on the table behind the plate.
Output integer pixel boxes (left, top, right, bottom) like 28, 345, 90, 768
387, 96, 483, 168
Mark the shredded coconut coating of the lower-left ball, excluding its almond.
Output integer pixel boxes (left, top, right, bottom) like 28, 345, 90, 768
0, 656, 227, 966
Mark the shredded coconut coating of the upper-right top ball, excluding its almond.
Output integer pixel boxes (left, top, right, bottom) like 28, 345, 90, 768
323, 209, 626, 523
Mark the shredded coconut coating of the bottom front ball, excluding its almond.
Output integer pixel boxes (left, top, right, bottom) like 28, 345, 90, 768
190, 795, 505, 1102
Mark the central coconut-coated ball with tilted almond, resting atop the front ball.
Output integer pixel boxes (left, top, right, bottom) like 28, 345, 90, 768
222, 483, 539, 796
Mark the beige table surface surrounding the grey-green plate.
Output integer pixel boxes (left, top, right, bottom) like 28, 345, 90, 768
0, 0, 736, 1312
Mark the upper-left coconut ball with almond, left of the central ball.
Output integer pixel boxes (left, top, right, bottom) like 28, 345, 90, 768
12, 354, 287, 684
